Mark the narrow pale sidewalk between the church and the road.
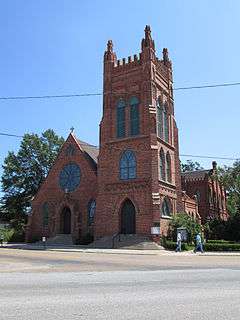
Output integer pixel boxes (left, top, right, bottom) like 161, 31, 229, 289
0, 243, 240, 257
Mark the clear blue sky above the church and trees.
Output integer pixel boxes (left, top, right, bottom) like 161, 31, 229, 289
0, 0, 240, 185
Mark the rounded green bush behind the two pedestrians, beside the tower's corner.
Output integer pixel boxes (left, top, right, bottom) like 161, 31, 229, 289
170, 213, 201, 243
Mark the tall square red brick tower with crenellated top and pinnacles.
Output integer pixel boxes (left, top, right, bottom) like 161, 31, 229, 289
95, 26, 182, 238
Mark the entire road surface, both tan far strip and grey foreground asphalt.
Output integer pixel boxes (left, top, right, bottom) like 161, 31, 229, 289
0, 250, 240, 320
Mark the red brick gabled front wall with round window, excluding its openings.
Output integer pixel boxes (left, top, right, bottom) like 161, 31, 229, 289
27, 134, 97, 241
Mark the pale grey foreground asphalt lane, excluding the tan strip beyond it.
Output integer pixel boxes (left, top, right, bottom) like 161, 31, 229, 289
0, 269, 240, 320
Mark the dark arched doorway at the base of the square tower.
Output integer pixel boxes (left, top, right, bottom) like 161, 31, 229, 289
121, 199, 136, 234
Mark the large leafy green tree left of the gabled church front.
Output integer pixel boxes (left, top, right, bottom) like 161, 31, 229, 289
1, 129, 64, 228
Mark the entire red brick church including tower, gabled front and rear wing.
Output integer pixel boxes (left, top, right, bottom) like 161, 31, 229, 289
27, 26, 226, 242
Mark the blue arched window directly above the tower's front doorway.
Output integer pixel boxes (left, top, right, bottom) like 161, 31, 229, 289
120, 150, 136, 180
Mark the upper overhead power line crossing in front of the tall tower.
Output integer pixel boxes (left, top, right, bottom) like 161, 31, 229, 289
0, 82, 240, 100
